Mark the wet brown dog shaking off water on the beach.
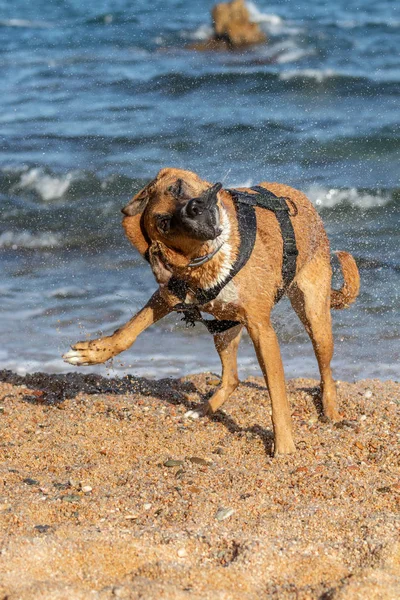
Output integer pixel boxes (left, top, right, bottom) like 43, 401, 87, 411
64, 169, 360, 455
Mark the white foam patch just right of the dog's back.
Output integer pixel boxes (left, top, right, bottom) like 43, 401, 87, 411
307, 186, 391, 209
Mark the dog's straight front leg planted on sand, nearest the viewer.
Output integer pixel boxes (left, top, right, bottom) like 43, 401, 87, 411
247, 317, 296, 456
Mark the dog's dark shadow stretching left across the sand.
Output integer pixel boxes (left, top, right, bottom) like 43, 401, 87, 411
0, 370, 274, 454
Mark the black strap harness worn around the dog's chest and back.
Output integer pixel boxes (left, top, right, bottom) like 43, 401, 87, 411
164, 186, 298, 334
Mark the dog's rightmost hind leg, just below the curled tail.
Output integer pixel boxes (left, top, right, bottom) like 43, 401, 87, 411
288, 256, 340, 421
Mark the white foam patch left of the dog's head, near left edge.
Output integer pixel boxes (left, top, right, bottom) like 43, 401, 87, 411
11, 168, 76, 202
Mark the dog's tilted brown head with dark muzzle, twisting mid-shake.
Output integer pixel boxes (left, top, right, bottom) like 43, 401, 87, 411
122, 169, 222, 259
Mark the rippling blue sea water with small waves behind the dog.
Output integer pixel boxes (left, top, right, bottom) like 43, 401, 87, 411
0, 0, 400, 379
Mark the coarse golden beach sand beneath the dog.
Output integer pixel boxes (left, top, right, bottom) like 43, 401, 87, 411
0, 372, 400, 600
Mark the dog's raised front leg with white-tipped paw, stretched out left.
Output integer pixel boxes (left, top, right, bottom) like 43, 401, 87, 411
63, 290, 171, 366
